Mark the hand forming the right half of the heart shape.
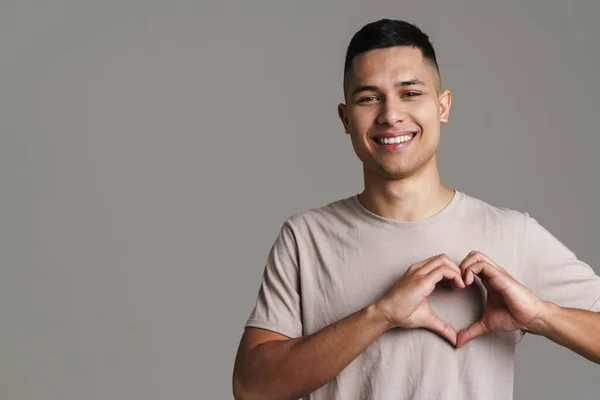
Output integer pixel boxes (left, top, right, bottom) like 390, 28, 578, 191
456, 251, 545, 348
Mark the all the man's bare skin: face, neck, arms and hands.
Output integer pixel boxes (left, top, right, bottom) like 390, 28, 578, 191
233, 47, 600, 399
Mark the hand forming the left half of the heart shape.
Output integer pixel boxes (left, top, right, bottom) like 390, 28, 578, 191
377, 254, 465, 345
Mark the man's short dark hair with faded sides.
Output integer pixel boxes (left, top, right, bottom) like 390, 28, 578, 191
344, 18, 441, 96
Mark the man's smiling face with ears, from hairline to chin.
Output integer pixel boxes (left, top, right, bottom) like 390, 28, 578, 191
338, 46, 451, 179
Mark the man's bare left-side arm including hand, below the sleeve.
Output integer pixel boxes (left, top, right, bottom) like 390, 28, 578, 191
233, 254, 465, 400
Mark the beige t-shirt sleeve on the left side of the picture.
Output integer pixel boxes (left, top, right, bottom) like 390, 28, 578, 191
245, 219, 302, 338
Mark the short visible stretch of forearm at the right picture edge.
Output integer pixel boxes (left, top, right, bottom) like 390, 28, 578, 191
530, 302, 600, 364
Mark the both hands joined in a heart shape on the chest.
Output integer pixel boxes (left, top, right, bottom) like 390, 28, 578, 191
377, 251, 545, 348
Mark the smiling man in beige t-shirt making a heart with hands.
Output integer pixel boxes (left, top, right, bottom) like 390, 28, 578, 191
233, 19, 600, 400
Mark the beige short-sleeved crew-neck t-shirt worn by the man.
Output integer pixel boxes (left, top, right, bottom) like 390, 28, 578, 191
246, 191, 600, 400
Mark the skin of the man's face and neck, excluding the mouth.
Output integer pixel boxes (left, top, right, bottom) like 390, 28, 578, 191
338, 47, 454, 225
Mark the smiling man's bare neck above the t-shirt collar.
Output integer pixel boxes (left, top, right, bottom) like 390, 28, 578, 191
358, 157, 454, 221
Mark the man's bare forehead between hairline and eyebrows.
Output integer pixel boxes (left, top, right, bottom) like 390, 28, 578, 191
350, 46, 435, 89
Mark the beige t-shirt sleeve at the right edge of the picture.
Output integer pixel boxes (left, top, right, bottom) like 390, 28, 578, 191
525, 213, 600, 311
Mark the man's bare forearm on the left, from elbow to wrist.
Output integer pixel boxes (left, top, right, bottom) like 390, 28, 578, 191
232, 305, 390, 399
